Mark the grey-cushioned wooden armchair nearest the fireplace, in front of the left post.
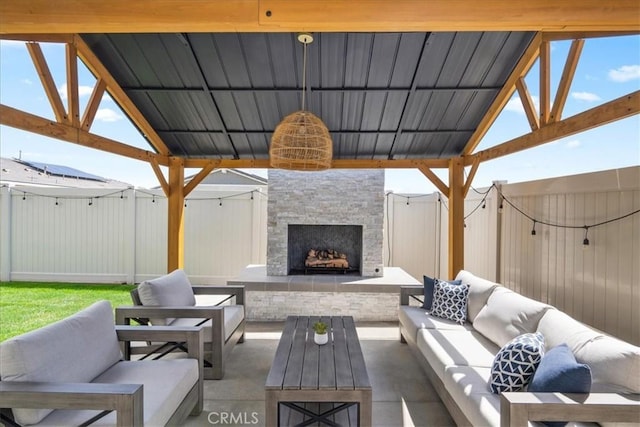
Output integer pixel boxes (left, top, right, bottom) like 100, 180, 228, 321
116, 269, 245, 379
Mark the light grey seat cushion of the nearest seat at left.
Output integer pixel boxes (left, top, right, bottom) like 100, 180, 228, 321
32, 359, 198, 427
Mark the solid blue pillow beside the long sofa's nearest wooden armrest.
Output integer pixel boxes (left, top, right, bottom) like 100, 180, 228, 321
527, 344, 591, 427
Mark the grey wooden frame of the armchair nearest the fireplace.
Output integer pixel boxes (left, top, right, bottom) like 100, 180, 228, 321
115, 285, 245, 380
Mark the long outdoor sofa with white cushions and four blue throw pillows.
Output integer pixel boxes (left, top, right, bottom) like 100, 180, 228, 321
399, 271, 640, 426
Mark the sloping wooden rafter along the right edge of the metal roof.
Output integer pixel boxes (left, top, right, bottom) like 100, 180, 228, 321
463, 33, 542, 155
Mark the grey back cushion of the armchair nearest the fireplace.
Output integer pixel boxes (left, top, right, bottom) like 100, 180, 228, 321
138, 269, 196, 325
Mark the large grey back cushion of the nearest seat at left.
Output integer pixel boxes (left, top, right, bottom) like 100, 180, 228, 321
0, 301, 122, 424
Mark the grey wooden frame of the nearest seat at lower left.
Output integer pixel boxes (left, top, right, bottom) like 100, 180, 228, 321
0, 326, 204, 427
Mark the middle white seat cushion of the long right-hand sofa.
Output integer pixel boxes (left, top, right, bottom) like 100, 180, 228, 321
417, 329, 500, 379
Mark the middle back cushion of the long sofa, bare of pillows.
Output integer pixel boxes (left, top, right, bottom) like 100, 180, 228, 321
473, 287, 551, 347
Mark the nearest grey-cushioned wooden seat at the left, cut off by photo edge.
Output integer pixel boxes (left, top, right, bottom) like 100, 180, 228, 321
0, 301, 203, 426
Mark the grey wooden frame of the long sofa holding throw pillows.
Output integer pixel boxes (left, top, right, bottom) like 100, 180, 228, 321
400, 286, 640, 427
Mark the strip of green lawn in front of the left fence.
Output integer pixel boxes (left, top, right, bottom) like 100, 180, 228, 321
0, 282, 135, 341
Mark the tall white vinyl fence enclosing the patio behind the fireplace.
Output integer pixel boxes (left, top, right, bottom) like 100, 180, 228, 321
0, 167, 640, 344
